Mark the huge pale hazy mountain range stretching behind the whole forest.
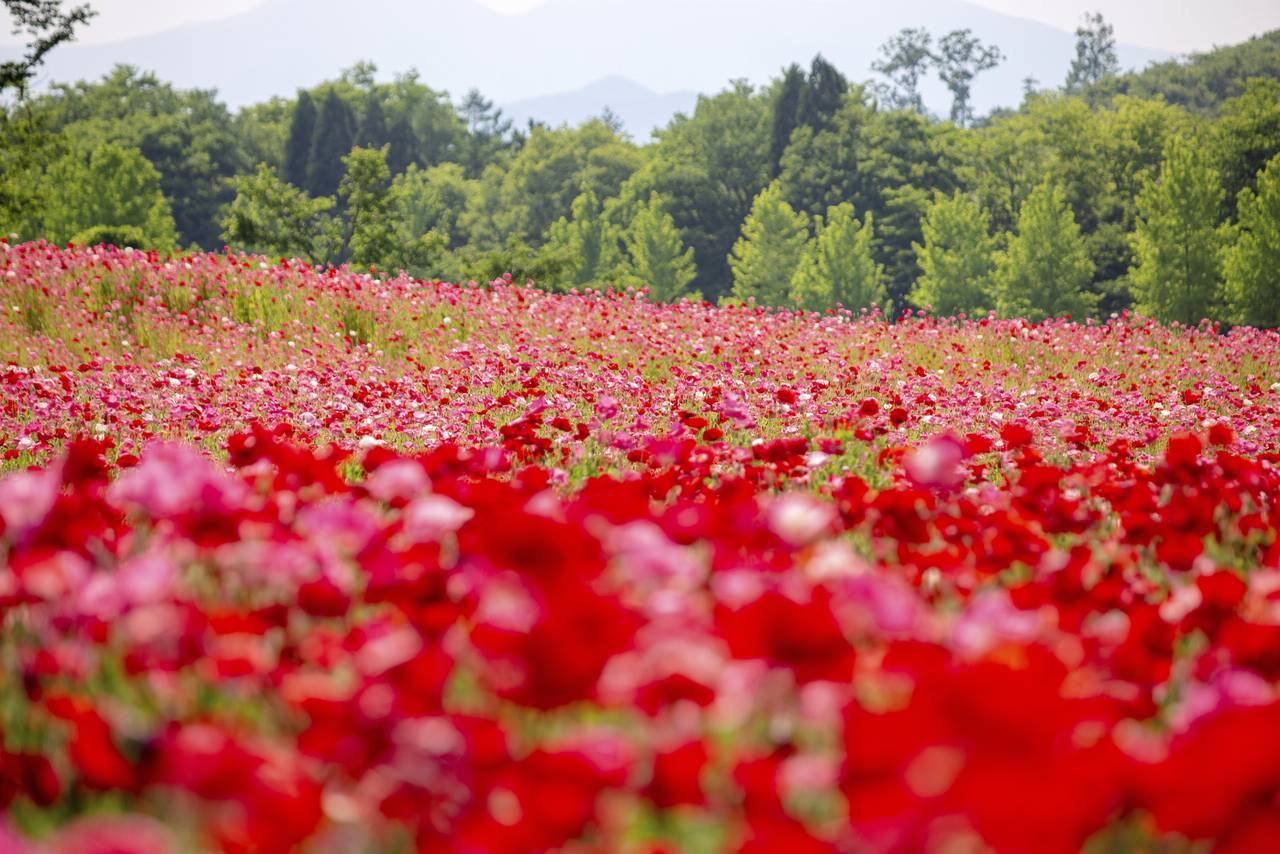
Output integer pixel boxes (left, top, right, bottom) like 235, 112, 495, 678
0, 0, 1169, 121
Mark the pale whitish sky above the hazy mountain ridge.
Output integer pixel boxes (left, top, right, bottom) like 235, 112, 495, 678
0, 0, 1280, 52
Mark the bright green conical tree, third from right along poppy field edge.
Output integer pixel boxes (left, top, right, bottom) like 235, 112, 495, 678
996, 181, 1097, 321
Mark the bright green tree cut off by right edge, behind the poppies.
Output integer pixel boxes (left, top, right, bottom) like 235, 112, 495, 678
1222, 155, 1280, 328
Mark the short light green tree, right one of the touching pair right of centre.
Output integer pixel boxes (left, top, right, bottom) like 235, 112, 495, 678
791, 202, 884, 311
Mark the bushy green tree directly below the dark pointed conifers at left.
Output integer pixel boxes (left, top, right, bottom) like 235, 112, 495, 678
221, 164, 342, 264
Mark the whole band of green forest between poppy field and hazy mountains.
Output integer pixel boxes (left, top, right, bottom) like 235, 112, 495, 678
0, 17, 1280, 326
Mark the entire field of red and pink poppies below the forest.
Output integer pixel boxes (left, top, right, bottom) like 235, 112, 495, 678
0, 243, 1280, 854
